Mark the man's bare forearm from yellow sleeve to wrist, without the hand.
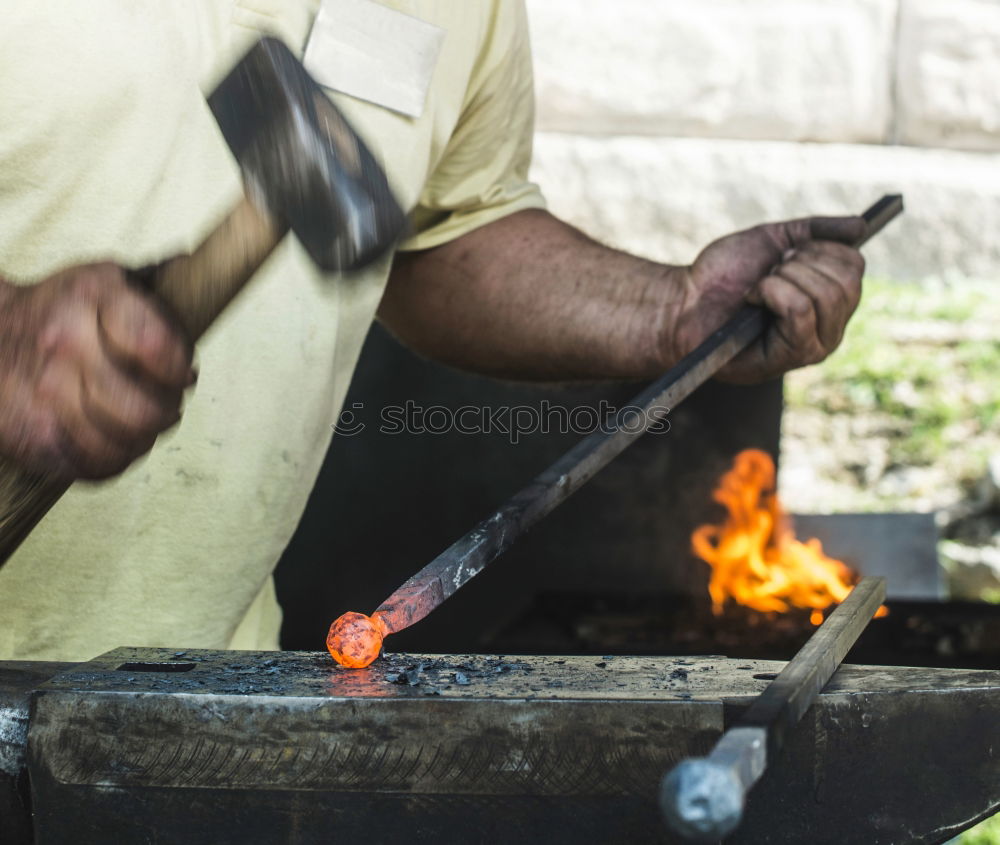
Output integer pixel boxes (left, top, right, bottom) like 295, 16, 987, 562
379, 211, 683, 380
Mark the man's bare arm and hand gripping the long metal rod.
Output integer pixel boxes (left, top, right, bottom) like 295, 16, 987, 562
379, 211, 865, 383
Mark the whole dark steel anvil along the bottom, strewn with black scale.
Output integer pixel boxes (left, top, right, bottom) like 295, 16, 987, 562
0, 648, 1000, 845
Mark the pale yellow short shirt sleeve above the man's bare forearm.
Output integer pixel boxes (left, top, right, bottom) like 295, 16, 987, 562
400, 0, 545, 250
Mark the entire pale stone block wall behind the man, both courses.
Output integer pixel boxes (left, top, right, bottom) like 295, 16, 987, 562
528, 0, 1000, 281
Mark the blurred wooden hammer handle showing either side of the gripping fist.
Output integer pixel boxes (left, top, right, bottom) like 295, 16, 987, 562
0, 198, 288, 567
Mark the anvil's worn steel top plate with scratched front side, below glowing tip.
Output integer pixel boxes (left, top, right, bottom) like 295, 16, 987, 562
32, 649, 732, 801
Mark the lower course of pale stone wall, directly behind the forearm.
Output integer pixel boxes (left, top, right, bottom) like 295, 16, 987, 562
533, 133, 1000, 282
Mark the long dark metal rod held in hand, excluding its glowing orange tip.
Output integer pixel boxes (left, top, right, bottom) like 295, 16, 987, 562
376, 195, 903, 633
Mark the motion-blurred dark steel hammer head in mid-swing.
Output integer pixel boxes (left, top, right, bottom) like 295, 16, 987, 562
208, 38, 406, 270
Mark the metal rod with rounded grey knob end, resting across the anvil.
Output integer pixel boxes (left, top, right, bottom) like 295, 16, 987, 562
660, 577, 885, 842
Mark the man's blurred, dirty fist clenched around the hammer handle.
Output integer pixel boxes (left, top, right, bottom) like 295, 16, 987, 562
0, 264, 194, 479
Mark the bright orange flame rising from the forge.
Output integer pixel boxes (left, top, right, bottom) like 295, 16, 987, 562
691, 449, 887, 625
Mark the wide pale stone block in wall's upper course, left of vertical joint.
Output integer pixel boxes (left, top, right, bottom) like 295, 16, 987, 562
528, 0, 897, 143
